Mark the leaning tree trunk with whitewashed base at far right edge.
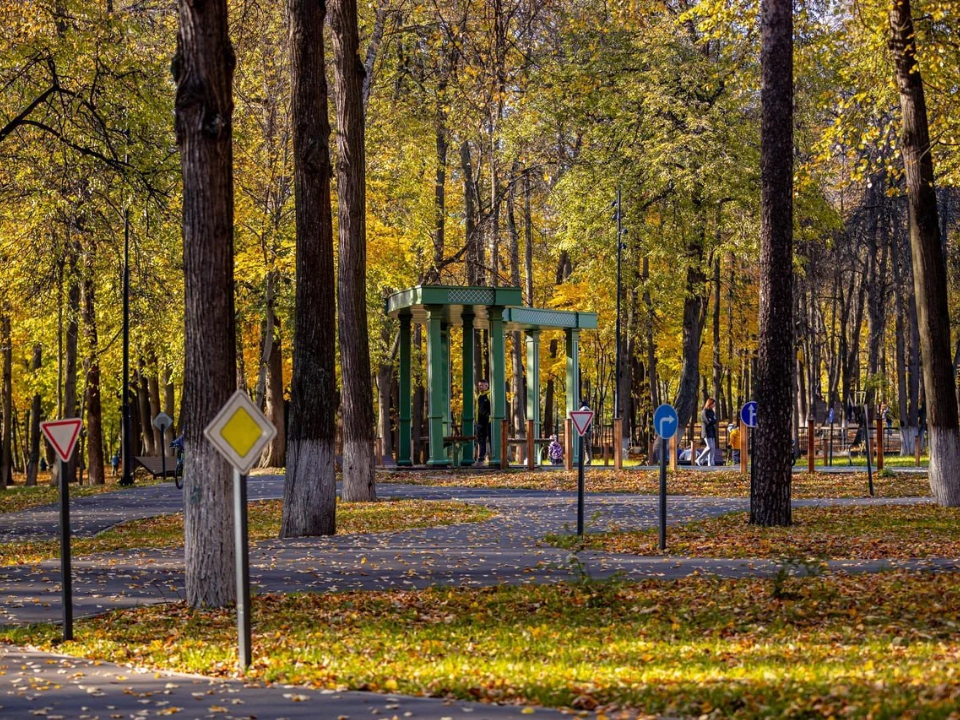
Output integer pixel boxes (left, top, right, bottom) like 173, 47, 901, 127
890, 0, 960, 506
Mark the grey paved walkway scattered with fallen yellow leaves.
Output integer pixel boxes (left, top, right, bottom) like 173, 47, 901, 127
0, 476, 944, 718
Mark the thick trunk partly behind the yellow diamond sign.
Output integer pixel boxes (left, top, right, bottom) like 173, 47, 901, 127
172, 0, 237, 607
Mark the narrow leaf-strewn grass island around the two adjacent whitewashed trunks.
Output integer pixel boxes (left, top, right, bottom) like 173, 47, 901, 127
0, 500, 494, 565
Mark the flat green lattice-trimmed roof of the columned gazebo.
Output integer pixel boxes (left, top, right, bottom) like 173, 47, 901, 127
387, 285, 597, 331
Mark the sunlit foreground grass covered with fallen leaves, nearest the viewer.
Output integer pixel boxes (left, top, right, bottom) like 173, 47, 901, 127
7, 572, 960, 718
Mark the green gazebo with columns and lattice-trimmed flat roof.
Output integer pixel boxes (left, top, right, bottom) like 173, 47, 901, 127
387, 285, 597, 467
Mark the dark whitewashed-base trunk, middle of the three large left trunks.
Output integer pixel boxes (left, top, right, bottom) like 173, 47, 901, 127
280, 0, 340, 537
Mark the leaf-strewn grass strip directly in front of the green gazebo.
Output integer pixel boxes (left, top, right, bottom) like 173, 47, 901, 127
377, 468, 930, 498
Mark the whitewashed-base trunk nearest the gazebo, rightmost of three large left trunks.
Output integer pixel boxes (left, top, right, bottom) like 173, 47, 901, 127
330, 0, 377, 502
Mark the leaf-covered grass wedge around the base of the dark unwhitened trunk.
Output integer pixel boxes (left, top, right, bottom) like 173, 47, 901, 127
568, 504, 960, 560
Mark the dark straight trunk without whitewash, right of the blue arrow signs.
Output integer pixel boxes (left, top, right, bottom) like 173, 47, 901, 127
750, 0, 796, 526
